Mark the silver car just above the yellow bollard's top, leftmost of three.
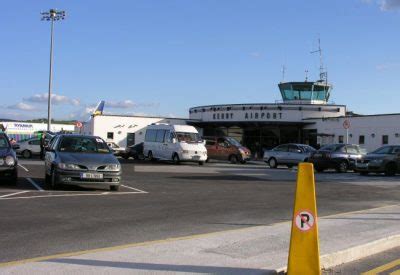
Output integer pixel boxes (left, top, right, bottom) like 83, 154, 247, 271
264, 143, 315, 168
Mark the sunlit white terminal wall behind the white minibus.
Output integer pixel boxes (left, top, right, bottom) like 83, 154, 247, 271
80, 115, 188, 147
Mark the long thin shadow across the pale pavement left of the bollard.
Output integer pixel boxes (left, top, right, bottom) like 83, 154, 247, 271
46, 258, 276, 274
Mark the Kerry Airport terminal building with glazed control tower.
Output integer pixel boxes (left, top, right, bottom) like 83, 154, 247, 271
83, 80, 400, 157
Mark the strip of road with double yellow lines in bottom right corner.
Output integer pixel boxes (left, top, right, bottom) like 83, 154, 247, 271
323, 247, 400, 275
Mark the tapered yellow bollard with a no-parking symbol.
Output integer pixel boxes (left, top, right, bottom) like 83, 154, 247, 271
287, 163, 321, 275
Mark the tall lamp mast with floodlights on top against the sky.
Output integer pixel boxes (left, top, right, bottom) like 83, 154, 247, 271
40, 9, 65, 131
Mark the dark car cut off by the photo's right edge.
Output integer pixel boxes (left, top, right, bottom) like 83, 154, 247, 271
356, 146, 400, 176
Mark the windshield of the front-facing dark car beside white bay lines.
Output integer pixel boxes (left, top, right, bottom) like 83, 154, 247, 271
59, 137, 110, 154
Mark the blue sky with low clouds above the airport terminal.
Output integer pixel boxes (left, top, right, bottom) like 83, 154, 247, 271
0, 0, 400, 120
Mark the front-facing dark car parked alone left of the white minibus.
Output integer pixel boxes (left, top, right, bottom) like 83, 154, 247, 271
45, 134, 121, 191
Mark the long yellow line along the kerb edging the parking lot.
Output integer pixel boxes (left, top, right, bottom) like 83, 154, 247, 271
0, 204, 400, 268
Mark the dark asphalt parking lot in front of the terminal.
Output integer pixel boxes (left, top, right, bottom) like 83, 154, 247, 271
0, 160, 400, 268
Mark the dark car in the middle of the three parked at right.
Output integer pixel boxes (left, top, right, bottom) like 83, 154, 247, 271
309, 144, 366, 173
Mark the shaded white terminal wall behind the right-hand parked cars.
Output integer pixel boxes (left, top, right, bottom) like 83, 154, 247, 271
304, 114, 400, 152
